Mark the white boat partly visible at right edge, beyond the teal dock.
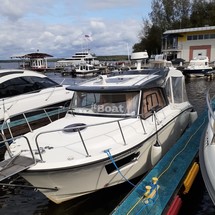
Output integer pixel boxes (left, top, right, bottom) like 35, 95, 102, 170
199, 86, 215, 205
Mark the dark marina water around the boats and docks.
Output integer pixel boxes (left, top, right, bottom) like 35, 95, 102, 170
0, 64, 215, 215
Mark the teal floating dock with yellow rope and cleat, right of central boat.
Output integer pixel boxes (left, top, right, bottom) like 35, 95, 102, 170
112, 111, 208, 215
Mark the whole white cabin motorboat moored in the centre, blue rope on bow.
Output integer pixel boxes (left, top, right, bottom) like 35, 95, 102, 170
0, 68, 196, 204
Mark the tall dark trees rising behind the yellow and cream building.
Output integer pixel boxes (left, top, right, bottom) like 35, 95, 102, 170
133, 0, 215, 56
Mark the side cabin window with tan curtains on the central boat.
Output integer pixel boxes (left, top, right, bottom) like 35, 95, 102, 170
141, 88, 166, 118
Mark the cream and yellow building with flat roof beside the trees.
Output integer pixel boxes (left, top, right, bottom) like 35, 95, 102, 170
162, 26, 215, 62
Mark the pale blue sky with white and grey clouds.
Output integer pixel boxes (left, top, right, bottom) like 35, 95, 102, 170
0, 0, 151, 60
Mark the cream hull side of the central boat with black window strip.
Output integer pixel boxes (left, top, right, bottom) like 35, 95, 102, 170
21, 109, 191, 204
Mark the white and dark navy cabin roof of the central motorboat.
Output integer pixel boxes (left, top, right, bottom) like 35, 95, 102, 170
67, 69, 169, 93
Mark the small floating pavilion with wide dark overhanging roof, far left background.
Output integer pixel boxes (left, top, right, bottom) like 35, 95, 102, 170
11, 52, 53, 72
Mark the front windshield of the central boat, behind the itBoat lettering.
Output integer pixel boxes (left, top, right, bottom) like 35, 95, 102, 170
71, 92, 140, 116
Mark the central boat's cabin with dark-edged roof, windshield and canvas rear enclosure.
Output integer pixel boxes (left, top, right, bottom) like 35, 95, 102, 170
69, 69, 187, 118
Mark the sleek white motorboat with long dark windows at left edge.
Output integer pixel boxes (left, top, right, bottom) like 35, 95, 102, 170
0, 69, 73, 121
